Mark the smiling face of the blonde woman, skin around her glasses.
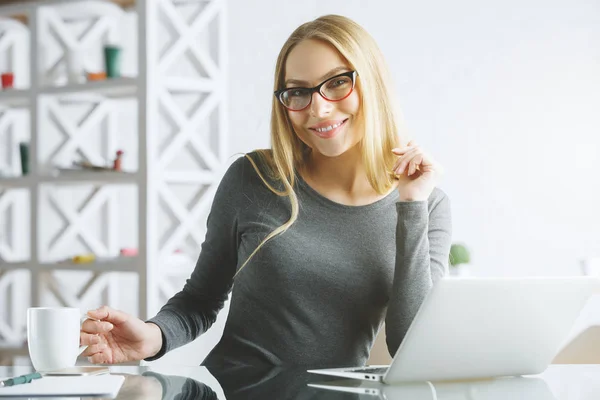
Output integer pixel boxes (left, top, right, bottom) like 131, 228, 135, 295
285, 40, 364, 157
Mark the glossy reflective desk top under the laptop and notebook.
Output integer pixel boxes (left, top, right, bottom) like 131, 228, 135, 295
0, 365, 600, 400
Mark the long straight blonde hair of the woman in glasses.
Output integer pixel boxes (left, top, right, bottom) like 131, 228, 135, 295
236, 15, 401, 275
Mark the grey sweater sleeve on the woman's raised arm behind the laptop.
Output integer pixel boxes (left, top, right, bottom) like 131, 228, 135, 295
385, 189, 452, 356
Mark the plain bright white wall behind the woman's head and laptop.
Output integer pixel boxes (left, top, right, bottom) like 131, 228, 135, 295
229, 0, 600, 276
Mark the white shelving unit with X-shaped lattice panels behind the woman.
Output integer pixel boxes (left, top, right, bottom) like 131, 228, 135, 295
0, 0, 227, 364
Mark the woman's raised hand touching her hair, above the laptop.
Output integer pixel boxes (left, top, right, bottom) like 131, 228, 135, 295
392, 141, 442, 201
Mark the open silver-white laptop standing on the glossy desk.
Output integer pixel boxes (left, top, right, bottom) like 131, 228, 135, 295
308, 277, 600, 384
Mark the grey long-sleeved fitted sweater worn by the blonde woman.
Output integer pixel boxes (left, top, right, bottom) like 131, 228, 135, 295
150, 154, 451, 367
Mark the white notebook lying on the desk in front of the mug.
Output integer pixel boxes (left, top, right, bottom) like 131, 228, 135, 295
0, 375, 125, 399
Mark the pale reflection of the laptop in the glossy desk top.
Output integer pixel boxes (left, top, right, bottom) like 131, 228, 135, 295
308, 377, 556, 400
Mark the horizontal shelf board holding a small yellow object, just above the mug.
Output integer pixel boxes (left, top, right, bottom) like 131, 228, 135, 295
0, 257, 139, 272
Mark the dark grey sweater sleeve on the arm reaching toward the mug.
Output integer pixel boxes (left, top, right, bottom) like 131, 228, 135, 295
148, 158, 245, 360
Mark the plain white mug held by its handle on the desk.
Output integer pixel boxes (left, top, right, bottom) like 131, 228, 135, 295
27, 307, 87, 372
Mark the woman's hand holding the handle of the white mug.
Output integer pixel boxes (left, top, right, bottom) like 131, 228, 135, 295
79, 306, 162, 364
